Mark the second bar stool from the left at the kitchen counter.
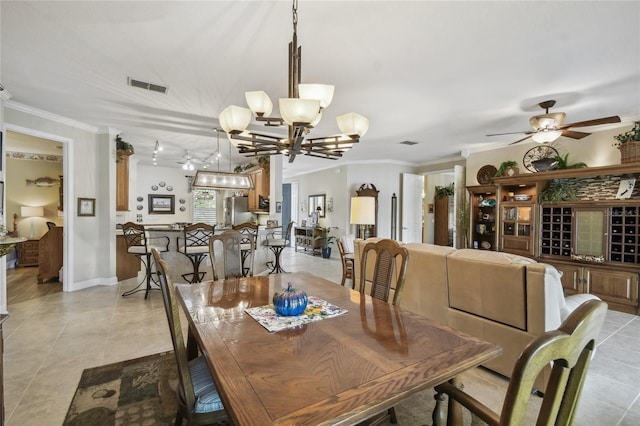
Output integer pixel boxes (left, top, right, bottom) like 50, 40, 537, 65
176, 222, 216, 284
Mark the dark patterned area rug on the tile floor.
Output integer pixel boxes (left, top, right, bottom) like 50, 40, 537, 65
64, 352, 228, 426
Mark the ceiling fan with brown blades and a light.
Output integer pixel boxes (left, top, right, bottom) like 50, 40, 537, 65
487, 99, 620, 145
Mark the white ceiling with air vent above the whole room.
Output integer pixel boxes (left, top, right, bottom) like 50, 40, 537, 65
0, 0, 640, 176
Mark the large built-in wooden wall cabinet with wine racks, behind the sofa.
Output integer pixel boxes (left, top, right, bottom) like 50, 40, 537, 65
482, 163, 640, 314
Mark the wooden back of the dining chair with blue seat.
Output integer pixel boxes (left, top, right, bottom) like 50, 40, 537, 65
151, 248, 196, 417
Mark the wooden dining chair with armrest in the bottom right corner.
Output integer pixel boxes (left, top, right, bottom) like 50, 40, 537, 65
433, 299, 607, 425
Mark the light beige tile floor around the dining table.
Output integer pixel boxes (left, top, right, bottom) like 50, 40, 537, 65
4, 249, 640, 426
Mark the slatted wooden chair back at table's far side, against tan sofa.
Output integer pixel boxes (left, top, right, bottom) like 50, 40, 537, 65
360, 239, 409, 305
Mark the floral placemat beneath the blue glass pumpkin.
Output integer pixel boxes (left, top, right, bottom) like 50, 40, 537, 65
244, 296, 348, 333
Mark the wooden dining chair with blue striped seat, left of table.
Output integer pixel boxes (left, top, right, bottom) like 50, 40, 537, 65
152, 249, 227, 426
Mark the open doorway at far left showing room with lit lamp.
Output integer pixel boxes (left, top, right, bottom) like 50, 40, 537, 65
2, 125, 71, 309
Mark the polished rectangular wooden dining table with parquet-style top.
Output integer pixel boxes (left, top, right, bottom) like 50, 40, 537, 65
176, 273, 501, 425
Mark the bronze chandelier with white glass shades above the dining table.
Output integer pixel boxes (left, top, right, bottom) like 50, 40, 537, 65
218, 0, 369, 163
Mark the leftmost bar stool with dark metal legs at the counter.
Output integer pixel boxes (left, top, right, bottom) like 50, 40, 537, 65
122, 222, 169, 299
